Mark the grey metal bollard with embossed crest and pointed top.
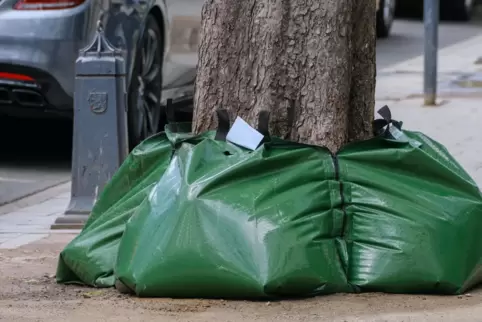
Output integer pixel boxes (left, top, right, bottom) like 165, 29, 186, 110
51, 22, 128, 229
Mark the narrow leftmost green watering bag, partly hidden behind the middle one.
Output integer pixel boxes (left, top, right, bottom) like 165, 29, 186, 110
56, 133, 176, 287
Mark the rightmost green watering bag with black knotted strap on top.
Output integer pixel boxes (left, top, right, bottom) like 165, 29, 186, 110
338, 107, 482, 294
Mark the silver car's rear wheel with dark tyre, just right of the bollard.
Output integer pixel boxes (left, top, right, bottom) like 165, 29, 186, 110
127, 15, 166, 150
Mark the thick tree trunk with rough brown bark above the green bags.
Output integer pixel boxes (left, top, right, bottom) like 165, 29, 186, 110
194, 0, 376, 151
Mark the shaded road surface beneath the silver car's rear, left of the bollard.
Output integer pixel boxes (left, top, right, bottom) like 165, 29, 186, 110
0, 117, 72, 206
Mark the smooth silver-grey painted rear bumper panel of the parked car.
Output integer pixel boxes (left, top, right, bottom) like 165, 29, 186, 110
0, 0, 93, 107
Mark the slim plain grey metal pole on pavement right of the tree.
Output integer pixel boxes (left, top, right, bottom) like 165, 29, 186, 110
423, 0, 440, 106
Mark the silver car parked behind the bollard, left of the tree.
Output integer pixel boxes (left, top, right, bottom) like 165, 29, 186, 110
0, 0, 203, 147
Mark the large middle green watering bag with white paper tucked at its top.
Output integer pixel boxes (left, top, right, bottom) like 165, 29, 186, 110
115, 112, 350, 298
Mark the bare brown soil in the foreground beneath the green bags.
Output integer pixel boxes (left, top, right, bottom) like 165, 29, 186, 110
0, 234, 482, 322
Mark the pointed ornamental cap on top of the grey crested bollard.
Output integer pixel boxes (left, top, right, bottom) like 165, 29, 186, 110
76, 20, 126, 76
